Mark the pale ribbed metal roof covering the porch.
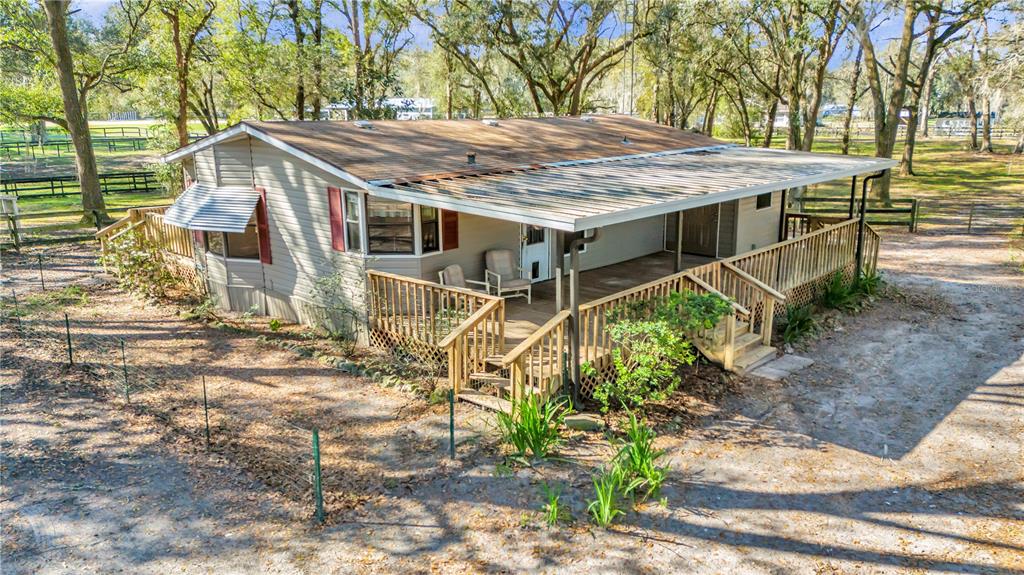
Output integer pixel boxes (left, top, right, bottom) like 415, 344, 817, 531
370, 145, 898, 231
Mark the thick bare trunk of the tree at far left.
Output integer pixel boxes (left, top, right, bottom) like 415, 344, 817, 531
43, 0, 110, 224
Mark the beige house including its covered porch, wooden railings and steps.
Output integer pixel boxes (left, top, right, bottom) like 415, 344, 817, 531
121, 116, 895, 405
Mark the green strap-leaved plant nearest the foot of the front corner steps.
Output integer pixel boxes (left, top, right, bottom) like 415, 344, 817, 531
497, 394, 566, 459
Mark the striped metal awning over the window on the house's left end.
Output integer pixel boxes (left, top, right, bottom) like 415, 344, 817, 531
164, 183, 259, 233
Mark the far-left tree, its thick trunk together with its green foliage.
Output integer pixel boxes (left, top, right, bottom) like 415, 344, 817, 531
0, 0, 151, 224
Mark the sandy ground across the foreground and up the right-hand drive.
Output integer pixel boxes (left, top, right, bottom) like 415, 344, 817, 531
0, 229, 1024, 573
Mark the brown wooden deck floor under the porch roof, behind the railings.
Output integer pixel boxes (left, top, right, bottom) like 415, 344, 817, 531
505, 252, 715, 349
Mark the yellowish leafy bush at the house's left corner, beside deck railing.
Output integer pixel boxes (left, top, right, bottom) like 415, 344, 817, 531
99, 229, 179, 298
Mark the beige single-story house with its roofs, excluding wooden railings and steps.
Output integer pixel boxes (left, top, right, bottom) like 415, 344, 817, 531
151, 116, 894, 403
